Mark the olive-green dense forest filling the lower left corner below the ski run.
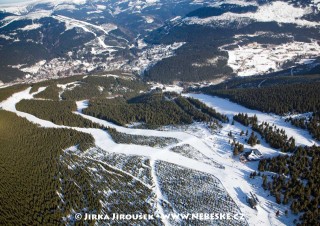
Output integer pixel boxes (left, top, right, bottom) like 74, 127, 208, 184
0, 110, 100, 225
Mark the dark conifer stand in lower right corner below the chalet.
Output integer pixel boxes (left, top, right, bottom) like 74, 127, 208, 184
259, 146, 320, 226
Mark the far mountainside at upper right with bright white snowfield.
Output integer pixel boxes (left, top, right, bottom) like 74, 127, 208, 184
147, 1, 320, 81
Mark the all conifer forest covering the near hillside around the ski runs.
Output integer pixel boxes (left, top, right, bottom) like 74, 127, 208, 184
0, 72, 320, 225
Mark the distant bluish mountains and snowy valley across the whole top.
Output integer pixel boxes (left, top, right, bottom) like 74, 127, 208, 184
0, 0, 320, 83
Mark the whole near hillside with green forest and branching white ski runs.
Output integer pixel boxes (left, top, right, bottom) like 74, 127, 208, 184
0, 73, 319, 225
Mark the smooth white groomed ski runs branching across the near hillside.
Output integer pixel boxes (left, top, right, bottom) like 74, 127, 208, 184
0, 87, 319, 225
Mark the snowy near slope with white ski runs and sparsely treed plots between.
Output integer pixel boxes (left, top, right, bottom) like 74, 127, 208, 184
0, 87, 318, 225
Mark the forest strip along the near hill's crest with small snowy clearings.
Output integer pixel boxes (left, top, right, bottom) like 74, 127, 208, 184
30, 72, 149, 100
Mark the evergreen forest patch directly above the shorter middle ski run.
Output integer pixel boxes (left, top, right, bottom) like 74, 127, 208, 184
83, 94, 192, 127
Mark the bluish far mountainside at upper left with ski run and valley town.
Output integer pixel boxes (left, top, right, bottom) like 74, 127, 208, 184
0, 0, 208, 82
